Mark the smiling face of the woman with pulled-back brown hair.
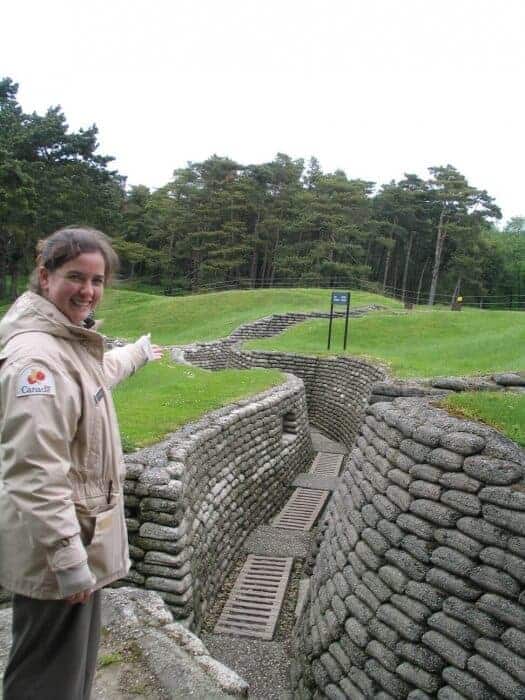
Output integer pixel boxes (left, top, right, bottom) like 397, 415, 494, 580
39, 251, 106, 325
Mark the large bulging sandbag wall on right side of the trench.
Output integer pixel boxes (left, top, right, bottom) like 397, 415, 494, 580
292, 399, 525, 700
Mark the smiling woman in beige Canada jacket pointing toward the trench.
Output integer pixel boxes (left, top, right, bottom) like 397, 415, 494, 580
0, 228, 162, 700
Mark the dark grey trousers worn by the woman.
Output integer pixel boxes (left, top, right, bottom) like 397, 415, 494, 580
3, 591, 100, 700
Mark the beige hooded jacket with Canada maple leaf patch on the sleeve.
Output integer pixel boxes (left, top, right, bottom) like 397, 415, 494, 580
0, 292, 147, 599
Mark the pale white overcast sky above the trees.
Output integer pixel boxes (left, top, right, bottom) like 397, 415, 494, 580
0, 0, 525, 219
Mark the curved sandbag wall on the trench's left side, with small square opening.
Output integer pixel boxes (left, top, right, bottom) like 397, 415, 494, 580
124, 376, 312, 630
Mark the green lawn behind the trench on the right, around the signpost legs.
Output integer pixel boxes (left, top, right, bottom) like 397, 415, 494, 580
244, 309, 525, 378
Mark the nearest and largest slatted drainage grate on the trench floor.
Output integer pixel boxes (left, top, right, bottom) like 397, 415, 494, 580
215, 554, 293, 640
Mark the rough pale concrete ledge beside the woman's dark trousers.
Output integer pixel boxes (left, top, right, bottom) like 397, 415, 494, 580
0, 588, 248, 700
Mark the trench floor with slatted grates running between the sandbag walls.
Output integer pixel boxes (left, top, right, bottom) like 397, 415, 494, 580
201, 428, 347, 700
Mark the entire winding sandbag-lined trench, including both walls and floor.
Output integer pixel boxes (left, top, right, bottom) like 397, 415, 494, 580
2, 308, 525, 700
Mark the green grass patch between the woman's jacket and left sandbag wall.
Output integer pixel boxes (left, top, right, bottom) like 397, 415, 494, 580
114, 359, 284, 452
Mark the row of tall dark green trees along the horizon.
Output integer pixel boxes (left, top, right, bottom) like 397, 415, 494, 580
0, 78, 525, 308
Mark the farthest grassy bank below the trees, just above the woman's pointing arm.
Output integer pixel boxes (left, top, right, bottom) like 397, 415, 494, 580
97, 289, 401, 345
